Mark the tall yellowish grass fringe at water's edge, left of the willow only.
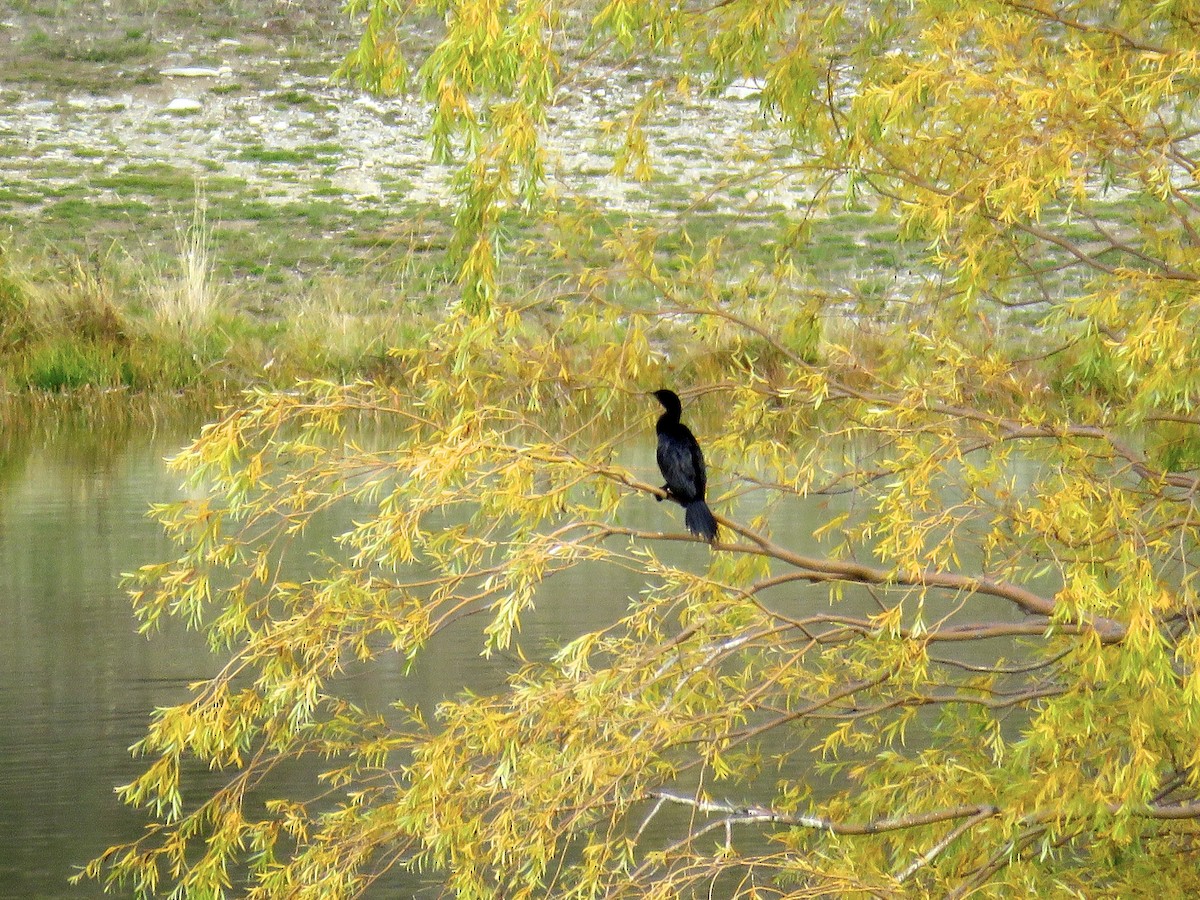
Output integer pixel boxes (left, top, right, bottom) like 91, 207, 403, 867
0, 228, 441, 392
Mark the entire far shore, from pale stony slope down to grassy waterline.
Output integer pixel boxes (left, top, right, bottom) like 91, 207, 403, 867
0, 0, 940, 395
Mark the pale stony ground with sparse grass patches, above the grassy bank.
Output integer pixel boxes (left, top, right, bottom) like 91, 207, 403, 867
0, 0, 816, 278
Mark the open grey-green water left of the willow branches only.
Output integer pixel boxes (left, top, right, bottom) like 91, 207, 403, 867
0, 415, 210, 898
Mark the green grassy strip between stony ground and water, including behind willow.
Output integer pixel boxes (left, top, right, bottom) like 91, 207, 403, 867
0, 187, 931, 392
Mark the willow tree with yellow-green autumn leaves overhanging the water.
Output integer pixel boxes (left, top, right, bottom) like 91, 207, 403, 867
79, 0, 1200, 898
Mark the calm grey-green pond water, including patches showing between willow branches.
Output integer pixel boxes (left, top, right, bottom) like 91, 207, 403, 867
0, 412, 1041, 900
